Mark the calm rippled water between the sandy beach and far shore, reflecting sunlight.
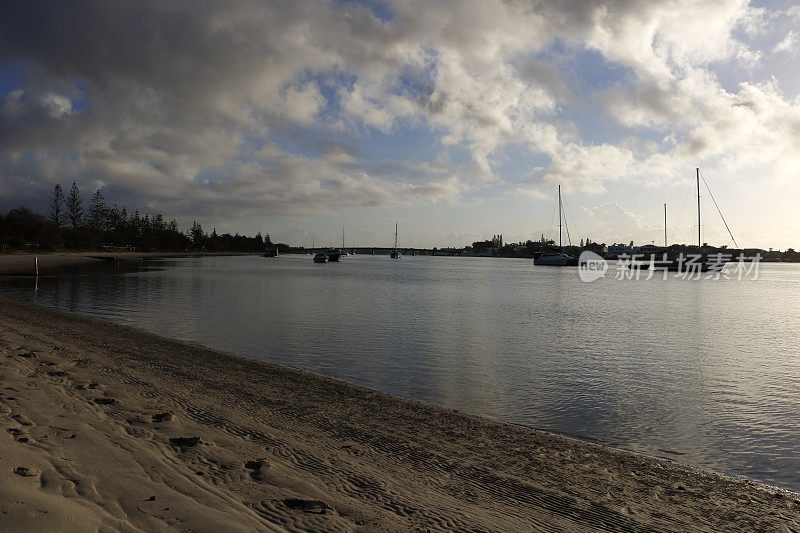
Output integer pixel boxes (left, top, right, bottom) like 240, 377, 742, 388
0, 256, 800, 490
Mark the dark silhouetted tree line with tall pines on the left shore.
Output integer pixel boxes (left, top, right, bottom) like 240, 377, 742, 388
0, 182, 271, 253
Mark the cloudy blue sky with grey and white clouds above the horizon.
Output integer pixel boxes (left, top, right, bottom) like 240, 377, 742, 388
0, 0, 800, 249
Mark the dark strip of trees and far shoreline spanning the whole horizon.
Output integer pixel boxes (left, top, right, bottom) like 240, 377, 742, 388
0, 189, 800, 263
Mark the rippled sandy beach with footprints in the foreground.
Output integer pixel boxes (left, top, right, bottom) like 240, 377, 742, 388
0, 288, 800, 531
